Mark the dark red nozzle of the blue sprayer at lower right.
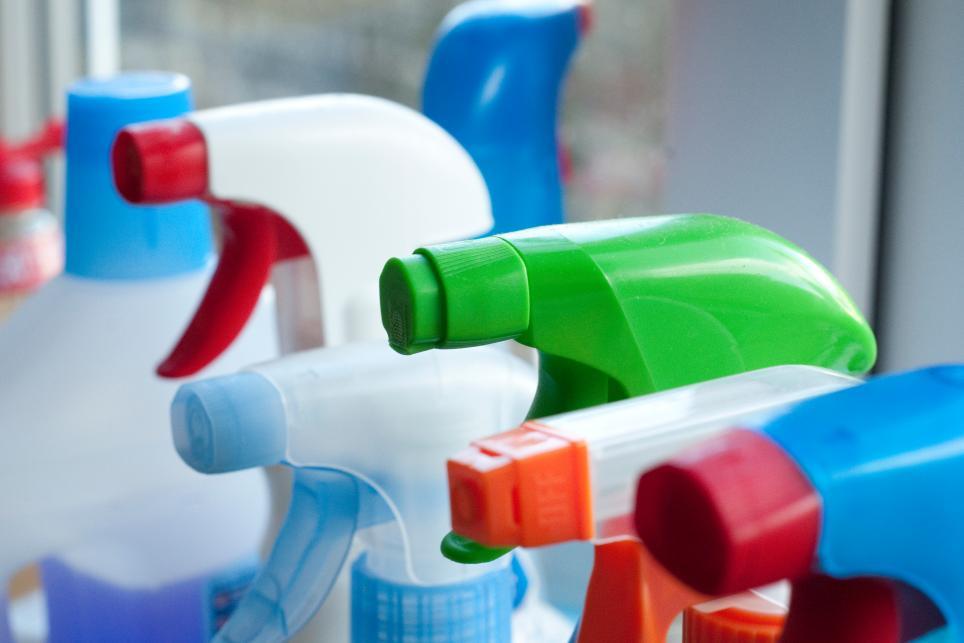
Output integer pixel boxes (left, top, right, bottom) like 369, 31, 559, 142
635, 430, 820, 596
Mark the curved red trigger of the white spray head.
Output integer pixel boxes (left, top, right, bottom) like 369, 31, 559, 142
157, 202, 308, 378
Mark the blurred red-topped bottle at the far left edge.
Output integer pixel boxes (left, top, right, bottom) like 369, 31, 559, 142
0, 120, 64, 315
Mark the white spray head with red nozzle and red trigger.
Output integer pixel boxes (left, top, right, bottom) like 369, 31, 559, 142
115, 94, 492, 377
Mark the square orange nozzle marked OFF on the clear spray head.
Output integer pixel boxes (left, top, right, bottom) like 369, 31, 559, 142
448, 422, 594, 547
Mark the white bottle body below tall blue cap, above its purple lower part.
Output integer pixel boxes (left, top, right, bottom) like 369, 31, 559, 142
0, 270, 276, 588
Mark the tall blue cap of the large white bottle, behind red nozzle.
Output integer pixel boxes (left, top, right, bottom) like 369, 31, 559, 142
64, 72, 212, 279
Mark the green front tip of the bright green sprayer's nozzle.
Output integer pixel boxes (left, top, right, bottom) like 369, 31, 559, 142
379, 254, 443, 355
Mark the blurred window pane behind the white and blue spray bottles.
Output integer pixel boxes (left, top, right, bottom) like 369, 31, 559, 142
121, 0, 670, 219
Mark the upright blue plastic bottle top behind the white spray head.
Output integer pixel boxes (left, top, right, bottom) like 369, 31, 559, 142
422, 0, 591, 233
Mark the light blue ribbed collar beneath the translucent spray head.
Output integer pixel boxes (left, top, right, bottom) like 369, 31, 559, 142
351, 555, 516, 643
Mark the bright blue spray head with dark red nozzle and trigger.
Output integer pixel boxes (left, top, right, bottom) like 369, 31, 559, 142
636, 365, 964, 643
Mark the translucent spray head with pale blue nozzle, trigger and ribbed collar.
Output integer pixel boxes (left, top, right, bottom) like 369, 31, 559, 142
165, 342, 568, 643
